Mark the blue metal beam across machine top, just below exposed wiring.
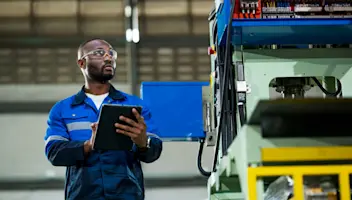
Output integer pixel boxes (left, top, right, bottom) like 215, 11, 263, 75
217, 0, 352, 45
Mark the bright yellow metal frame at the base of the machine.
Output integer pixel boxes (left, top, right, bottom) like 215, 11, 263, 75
248, 146, 352, 200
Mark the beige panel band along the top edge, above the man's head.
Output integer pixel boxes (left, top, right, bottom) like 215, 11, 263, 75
0, 0, 213, 35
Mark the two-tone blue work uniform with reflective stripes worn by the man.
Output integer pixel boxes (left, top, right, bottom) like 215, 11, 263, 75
44, 86, 162, 200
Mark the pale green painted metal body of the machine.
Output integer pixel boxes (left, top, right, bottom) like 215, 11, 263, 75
203, 16, 352, 200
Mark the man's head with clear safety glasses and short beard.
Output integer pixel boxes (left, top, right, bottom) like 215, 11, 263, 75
80, 40, 116, 83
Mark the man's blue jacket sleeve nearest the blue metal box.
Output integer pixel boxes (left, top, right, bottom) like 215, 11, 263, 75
138, 106, 163, 163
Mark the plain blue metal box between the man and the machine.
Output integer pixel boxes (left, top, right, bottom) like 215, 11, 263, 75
141, 82, 209, 141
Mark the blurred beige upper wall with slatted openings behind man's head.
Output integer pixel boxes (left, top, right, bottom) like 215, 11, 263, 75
0, 0, 213, 84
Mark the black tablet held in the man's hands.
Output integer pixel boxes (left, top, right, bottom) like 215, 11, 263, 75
94, 104, 142, 151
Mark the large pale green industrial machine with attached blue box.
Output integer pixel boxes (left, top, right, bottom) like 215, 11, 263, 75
141, 0, 352, 200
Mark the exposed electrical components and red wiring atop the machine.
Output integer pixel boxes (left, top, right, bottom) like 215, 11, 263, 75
233, 0, 352, 19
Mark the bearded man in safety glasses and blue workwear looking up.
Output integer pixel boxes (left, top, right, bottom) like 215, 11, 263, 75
45, 39, 162, 200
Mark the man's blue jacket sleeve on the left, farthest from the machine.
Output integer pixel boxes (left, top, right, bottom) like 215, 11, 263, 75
44, 102, 84, 166
